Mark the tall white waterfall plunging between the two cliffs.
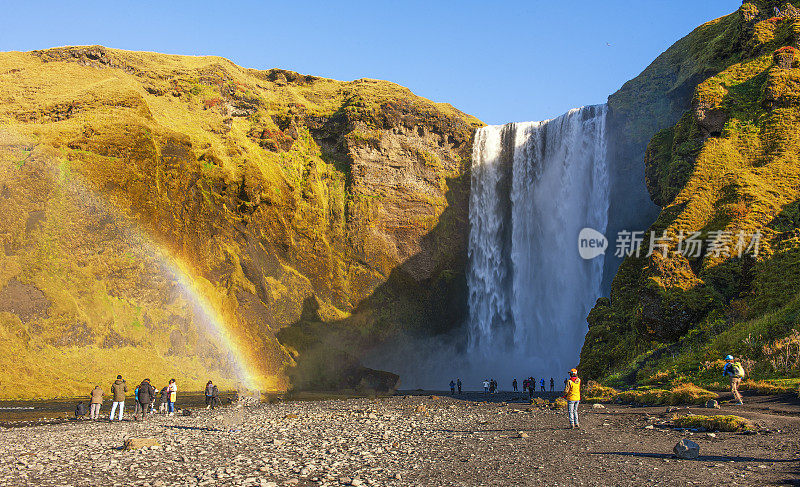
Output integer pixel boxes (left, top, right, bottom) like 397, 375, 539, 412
467, 105, 613, 382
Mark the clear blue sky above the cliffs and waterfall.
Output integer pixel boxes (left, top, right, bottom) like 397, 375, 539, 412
0, 0, 741, 124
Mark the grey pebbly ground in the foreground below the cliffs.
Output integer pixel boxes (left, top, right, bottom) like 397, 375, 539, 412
0, 393, 800, 486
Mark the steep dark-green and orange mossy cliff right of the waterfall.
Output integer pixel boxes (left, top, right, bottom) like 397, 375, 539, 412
581, 1, 800, 384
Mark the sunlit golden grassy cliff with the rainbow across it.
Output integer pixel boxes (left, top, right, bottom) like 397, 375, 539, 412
0, 47, 480, 398
